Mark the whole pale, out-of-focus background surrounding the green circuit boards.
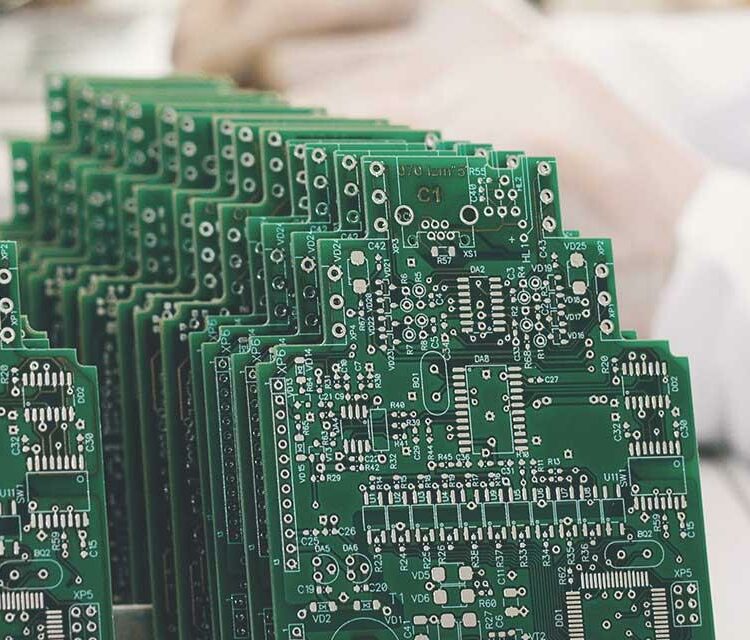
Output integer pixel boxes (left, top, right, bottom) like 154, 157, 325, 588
0, 0, 750, 640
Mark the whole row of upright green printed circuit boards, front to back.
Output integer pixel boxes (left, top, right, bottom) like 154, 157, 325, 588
0, 77, 714, 640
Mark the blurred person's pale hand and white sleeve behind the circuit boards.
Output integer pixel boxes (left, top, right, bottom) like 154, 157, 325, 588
174, 0, 750, 457
